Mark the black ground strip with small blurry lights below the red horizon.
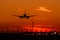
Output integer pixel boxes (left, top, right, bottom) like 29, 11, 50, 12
0, 33, 60, 40
